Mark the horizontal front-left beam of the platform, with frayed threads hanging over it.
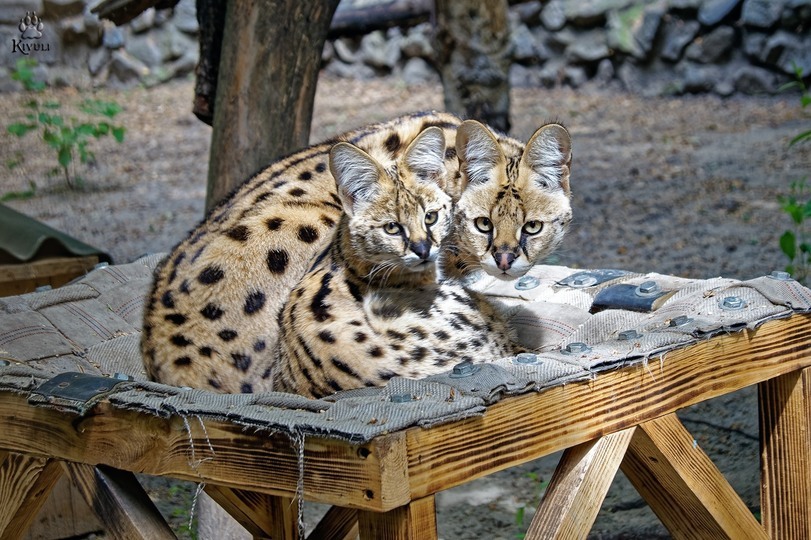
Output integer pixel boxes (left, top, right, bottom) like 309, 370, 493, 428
0, 392, 410, 511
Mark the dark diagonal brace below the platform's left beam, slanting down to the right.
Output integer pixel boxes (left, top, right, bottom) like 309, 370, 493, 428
62, 462, 175, 540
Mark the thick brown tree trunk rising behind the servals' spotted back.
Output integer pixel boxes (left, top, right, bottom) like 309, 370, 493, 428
206, 0, 338, 209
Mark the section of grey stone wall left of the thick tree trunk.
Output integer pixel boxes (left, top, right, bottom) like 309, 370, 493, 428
0, 0, 199, 90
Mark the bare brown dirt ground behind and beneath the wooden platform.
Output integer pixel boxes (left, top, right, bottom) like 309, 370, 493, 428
0, 75, 811, 540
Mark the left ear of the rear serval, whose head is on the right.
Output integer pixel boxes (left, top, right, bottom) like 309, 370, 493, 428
456, 120, 506, 188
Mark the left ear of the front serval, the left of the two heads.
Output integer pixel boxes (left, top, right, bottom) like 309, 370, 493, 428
329, 142, 386, 216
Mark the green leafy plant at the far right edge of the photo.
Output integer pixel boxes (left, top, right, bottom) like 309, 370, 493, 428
778, 65, 811, 283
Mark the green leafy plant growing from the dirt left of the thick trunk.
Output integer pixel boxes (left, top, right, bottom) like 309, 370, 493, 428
8, 58, 126, 189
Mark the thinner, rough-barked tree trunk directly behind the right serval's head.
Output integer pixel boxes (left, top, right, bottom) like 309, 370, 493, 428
435, 0, 510, 132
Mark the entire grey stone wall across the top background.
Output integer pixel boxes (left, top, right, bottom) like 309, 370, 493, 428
0, 0, 811, 96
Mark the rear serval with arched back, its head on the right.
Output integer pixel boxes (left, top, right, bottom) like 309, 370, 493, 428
142, 113, 571, 392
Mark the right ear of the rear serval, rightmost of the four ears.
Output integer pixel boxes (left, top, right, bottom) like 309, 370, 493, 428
521, 124, 572, 195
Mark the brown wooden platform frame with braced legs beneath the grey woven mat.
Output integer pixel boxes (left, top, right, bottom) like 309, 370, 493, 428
0, 315, 811, 540
